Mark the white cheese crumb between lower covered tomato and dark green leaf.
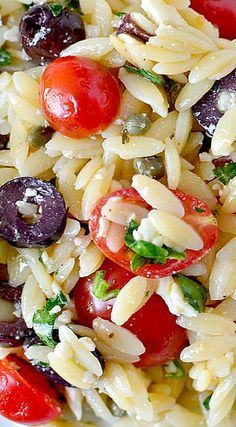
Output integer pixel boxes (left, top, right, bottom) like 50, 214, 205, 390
156, 276, 198, 317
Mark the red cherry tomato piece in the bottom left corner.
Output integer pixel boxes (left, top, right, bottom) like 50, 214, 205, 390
0, 355, 61, 425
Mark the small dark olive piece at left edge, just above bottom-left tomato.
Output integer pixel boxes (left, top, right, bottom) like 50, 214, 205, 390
0, 319, 32, 347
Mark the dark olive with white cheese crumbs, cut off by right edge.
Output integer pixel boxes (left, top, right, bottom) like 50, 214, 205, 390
192, 70, 236, 136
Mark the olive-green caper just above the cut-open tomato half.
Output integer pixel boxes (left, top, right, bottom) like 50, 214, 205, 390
133, 156, 165, 179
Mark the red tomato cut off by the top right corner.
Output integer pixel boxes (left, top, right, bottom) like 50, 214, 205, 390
191, 0, 236, 40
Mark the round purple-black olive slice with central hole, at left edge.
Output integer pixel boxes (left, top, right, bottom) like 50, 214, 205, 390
0, 177, 67, 248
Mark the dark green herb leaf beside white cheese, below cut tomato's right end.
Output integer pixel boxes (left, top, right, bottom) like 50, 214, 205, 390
177, 274, 207, 313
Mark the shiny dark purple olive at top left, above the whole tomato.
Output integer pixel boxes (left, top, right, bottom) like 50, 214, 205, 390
20, 4, 85, 65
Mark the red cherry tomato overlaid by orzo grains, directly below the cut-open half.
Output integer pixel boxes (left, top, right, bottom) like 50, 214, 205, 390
73, 260, 187, 368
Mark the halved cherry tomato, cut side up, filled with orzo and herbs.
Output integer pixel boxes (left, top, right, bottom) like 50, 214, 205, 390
89, 188, 217, 278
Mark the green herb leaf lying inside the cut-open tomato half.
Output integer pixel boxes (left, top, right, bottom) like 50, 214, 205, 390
124, 220, 185, 271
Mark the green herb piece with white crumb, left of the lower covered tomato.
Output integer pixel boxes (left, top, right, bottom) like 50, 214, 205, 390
33, 292, 67, 348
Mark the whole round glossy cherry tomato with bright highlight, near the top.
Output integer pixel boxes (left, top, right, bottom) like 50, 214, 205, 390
40, 56, 121, 138
